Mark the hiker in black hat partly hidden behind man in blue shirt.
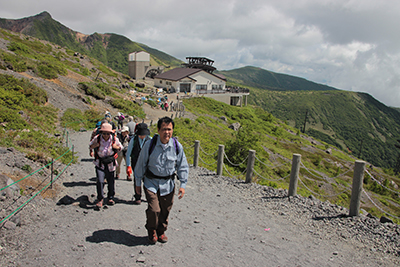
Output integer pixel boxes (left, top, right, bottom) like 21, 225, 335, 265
126, 122, 151, 205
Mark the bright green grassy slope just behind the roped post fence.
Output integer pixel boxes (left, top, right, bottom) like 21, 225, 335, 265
178, 97, 400, 223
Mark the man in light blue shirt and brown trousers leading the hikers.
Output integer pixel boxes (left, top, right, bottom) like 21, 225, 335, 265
134, 117, 189, 244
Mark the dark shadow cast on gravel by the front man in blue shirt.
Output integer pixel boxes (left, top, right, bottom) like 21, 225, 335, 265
86, 229, 149, 247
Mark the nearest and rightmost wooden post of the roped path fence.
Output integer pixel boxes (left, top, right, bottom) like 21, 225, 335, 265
349, 160, 365, 216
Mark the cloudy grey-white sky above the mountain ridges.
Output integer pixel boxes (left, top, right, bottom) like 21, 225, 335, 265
0, 0, 400, 107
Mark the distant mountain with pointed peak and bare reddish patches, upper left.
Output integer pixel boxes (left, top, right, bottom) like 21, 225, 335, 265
0, 11, 183, 74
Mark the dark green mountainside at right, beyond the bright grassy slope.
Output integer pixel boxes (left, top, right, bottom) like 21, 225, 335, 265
249, 89, 400, 168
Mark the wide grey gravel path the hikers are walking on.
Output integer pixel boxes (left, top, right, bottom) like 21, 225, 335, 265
0, 132, 400, 266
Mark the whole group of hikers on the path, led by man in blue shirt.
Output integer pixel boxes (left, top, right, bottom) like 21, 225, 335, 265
89, 112, 189, 244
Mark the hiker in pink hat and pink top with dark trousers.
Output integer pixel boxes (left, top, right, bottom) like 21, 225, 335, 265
89, 123, 122, 209
